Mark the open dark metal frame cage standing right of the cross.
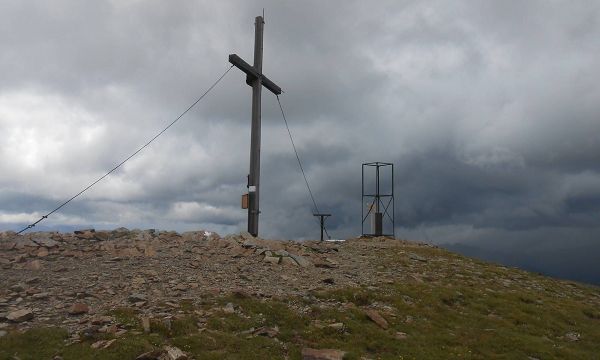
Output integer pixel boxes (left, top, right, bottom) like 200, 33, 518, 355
361, 161, 396, 237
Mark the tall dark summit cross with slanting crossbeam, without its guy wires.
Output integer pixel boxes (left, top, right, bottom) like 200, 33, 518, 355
229, 16, 281, 236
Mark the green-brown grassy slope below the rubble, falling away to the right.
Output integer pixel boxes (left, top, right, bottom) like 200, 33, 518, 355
0, 243, 600, 360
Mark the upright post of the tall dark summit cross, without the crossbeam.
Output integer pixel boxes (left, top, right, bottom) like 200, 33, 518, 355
248, 16, 265, 236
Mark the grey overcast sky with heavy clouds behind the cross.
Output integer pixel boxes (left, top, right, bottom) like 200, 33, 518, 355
0, 0, 600, 243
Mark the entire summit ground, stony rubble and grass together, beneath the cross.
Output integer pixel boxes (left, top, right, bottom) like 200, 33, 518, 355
0, 228, 600, 359
